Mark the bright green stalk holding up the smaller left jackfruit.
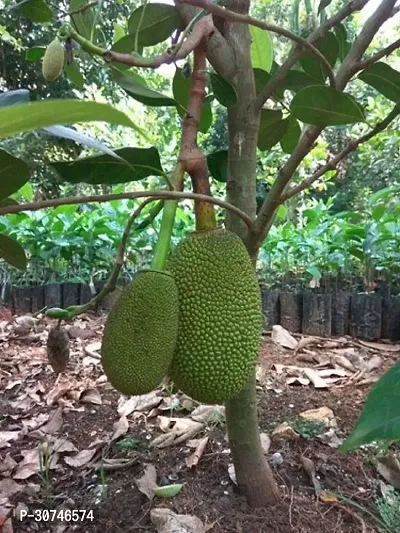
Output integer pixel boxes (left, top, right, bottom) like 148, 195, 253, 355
151, 162, 185, 270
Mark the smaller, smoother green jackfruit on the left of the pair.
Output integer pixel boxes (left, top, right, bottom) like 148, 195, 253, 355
101, 270, 178, 395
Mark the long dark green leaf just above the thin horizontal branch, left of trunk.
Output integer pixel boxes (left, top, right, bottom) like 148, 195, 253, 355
50, 147, 163, 185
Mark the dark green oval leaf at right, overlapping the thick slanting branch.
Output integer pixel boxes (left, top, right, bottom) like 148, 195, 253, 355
290, 85, 365, 127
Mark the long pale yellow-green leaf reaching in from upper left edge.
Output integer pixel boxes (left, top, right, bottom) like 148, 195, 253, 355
0, 99, 138, 139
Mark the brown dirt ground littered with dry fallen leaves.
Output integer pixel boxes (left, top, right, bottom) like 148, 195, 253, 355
0, 313, 400, 533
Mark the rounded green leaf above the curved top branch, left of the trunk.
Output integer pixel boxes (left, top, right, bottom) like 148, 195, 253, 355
128, 3, 182, 46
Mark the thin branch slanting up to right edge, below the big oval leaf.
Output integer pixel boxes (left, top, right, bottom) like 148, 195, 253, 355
279, 105, 400, 204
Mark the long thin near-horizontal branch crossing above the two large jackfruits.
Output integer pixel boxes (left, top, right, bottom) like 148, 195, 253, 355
0, 191, 253, 227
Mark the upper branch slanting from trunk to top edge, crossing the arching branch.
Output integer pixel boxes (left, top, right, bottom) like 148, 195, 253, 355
255, 0, 369, 109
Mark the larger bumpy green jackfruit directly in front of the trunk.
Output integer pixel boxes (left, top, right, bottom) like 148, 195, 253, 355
168, 229, 262, 404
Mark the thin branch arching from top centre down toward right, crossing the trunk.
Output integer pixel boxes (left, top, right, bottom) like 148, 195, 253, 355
179, 0, 335, 87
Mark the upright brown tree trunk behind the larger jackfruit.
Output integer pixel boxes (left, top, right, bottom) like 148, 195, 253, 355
226, 0, 278, 507
